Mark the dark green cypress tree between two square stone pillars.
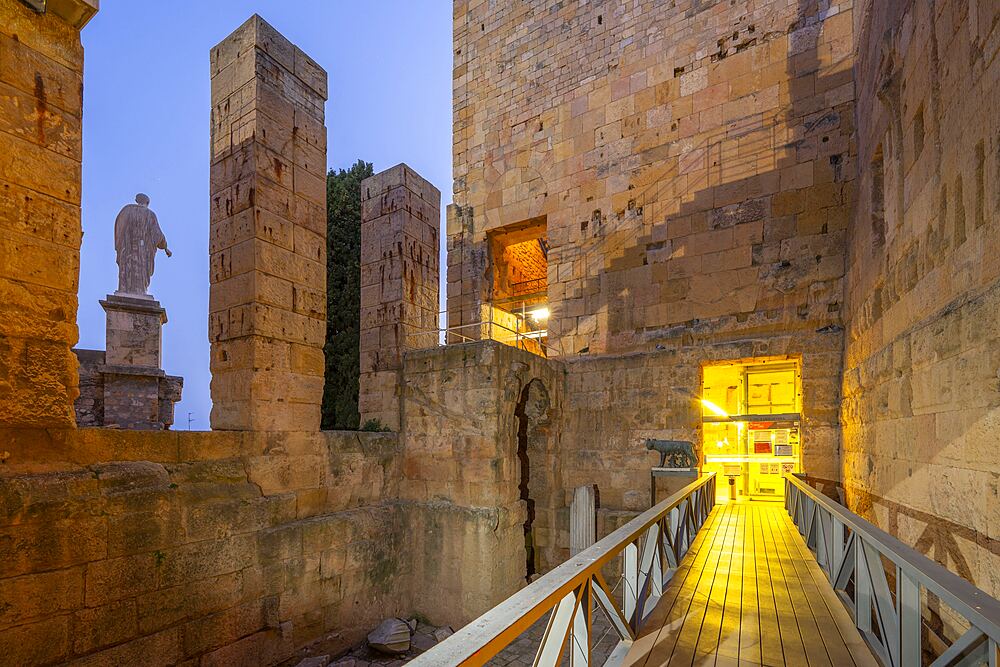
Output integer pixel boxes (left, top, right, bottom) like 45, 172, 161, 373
321, 160, 374, 429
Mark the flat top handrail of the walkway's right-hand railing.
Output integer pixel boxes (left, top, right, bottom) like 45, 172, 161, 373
786, 473, 1000, 641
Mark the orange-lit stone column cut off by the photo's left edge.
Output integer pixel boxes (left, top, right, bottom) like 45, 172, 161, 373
0, 0, 97, 428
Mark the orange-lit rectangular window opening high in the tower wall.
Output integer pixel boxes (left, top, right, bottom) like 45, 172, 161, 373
483, 216, 549, 355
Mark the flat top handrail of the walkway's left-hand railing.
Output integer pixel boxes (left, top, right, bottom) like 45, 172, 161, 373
411, 472, 716, 667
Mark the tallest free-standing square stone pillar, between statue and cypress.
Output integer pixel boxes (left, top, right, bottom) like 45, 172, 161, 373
209, 15, 327, 431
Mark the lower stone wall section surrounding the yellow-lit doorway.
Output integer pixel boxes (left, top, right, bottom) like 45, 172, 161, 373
559, 328, 842, 528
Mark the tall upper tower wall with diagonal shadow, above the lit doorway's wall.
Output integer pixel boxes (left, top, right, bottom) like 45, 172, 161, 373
448, 0, 854, 355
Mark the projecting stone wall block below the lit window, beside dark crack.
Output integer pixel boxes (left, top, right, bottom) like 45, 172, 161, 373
400, 341, 564, 627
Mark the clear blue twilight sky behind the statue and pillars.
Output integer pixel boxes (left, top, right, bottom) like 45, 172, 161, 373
79, 0, 452, 430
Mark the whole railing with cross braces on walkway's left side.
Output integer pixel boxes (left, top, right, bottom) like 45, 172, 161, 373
409, 473, 715, 667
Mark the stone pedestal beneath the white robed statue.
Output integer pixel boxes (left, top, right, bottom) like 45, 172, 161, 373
97, 294, 183, 430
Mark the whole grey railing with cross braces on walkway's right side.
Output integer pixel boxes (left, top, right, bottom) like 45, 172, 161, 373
785, 475, 1000, 667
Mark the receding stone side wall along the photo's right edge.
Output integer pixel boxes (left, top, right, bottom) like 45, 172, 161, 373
842, 0, 1000, 596
